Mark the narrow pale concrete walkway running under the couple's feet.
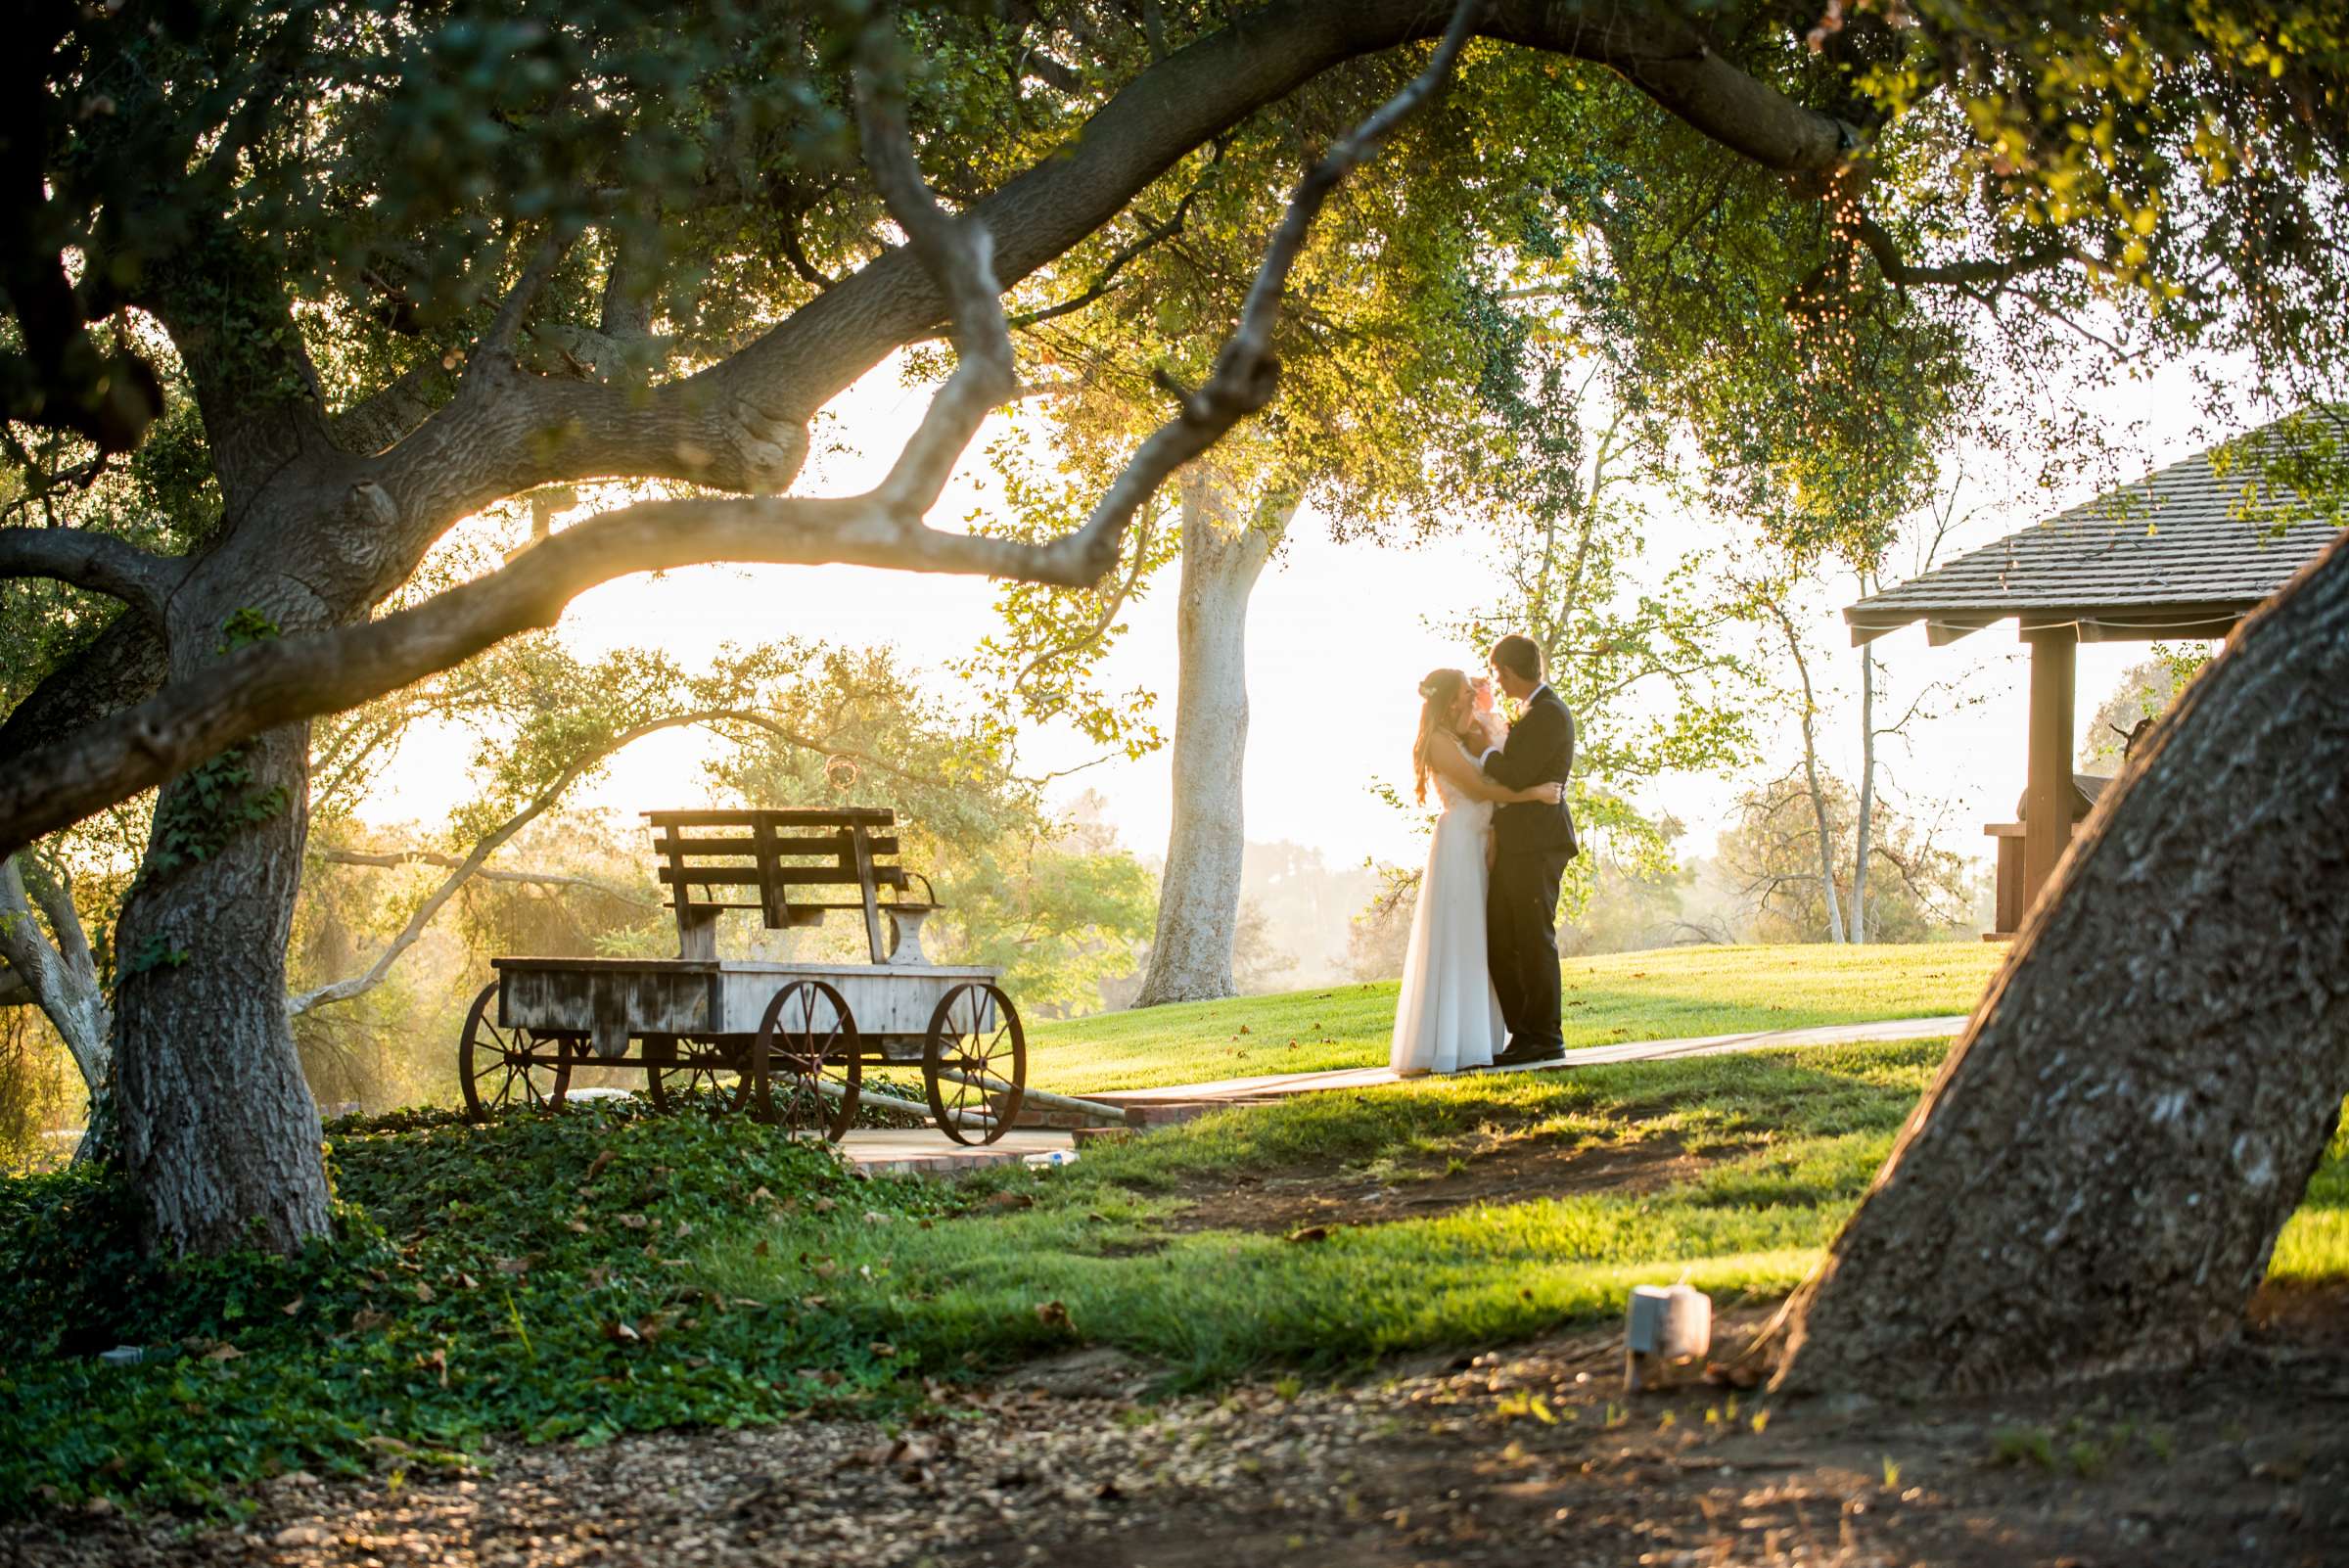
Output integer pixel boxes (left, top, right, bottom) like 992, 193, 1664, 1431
841, 1014, 1966, 1176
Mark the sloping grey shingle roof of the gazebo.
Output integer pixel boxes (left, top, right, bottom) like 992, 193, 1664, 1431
1844, 420, 2339, 643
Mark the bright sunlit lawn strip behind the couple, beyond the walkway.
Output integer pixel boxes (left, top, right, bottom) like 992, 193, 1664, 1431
1029, 942, 2006, 1094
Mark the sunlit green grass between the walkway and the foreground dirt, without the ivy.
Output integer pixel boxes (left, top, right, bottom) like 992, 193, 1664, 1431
703, 1039, 2349, 1387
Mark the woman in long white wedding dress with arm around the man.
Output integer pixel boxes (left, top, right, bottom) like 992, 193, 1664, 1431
1388, 669, 1557, 1078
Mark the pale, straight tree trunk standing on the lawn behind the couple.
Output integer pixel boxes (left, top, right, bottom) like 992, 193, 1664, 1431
1134, 465, 1297, 1007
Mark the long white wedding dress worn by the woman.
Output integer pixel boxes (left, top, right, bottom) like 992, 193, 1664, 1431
1388, 774, 1508, 1073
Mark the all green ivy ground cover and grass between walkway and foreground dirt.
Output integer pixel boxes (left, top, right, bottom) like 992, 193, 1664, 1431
0, 1039, 2349, 1514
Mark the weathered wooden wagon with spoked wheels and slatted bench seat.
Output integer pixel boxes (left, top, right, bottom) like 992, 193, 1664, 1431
458, 807, 1027, 1143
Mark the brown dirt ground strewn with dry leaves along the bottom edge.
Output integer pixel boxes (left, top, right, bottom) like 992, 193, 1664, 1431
0, 1296, 2349, 1568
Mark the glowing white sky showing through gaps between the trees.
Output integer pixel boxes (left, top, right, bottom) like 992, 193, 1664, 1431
362, 349, 2235, 882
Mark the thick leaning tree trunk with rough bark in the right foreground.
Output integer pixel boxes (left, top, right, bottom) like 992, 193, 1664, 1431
1780, 542, 2349, 1395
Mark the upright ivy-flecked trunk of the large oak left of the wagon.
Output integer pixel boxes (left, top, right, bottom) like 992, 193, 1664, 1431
115, 725, 327, 1251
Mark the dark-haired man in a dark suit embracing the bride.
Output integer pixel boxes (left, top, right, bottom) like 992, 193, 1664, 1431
1480, 636, 1576, 1068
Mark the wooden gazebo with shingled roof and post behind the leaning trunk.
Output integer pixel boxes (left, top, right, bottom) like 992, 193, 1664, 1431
1844, 420, 2335, 937
